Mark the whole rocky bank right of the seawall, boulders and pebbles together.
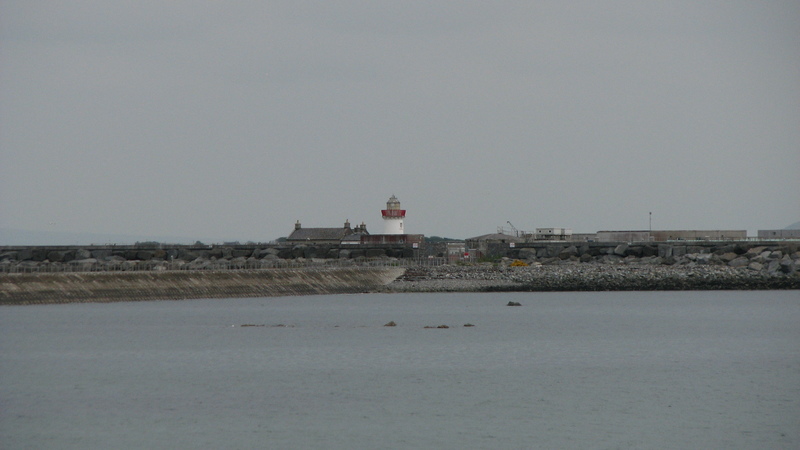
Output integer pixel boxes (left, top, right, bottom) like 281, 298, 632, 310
386, 241, 800, 292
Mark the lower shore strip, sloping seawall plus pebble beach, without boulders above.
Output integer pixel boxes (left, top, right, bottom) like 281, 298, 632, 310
0, 263, 800, 305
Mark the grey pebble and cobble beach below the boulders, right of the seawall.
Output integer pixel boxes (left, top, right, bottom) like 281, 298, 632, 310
382, 263, 800, 292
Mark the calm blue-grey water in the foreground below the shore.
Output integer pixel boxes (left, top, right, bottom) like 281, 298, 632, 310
0, 291, 800, 449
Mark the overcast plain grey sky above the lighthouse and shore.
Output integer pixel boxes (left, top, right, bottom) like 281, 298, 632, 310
0, 0, 800, 241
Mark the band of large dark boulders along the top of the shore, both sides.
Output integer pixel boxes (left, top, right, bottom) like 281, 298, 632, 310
0, 240, 800, 273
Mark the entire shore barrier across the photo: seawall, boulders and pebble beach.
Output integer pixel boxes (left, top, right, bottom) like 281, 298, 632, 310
0, 241, 800, 304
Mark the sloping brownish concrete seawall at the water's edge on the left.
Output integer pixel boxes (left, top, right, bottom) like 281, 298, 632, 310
0, 267, 404, 304
